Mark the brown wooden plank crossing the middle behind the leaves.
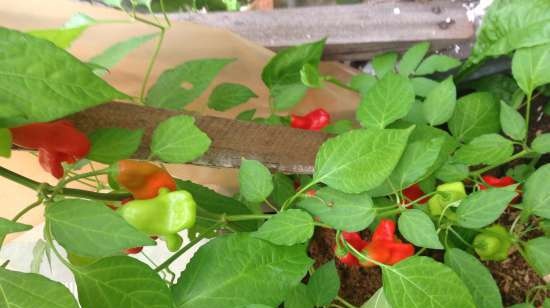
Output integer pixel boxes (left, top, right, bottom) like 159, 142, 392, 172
69, 102, 329, 174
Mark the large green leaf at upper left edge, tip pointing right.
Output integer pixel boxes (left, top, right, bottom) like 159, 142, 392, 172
0, 28, 128, 127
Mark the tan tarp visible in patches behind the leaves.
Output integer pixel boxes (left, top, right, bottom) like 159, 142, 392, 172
0, 0, 358, 236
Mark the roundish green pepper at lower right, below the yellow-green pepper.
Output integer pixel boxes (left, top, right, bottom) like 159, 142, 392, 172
473, 224, 512, 261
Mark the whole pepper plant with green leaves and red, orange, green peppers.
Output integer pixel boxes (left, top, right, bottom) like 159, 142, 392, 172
0, 0, 550, 308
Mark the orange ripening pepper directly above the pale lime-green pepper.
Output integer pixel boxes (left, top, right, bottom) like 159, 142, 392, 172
113, 159, 176, 200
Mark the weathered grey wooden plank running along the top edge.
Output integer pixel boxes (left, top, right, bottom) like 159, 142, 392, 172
171, 0, 474, 60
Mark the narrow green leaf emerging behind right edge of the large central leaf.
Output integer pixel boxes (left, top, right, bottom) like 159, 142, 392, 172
369, 137, 444, 197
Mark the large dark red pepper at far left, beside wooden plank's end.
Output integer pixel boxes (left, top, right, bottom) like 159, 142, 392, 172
10, 120, 91, 179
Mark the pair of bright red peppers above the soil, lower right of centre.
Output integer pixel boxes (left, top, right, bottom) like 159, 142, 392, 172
334, 219, 414, 267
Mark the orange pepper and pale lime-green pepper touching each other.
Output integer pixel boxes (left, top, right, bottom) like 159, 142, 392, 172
112, 159, 197, 253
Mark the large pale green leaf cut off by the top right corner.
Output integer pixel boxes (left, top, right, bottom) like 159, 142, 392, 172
469, 0, 550, 63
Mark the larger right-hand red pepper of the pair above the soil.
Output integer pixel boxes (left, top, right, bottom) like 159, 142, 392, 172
361, 219, 414, 267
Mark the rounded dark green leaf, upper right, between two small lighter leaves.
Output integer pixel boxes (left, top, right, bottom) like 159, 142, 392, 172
449, 92, 500, 142
